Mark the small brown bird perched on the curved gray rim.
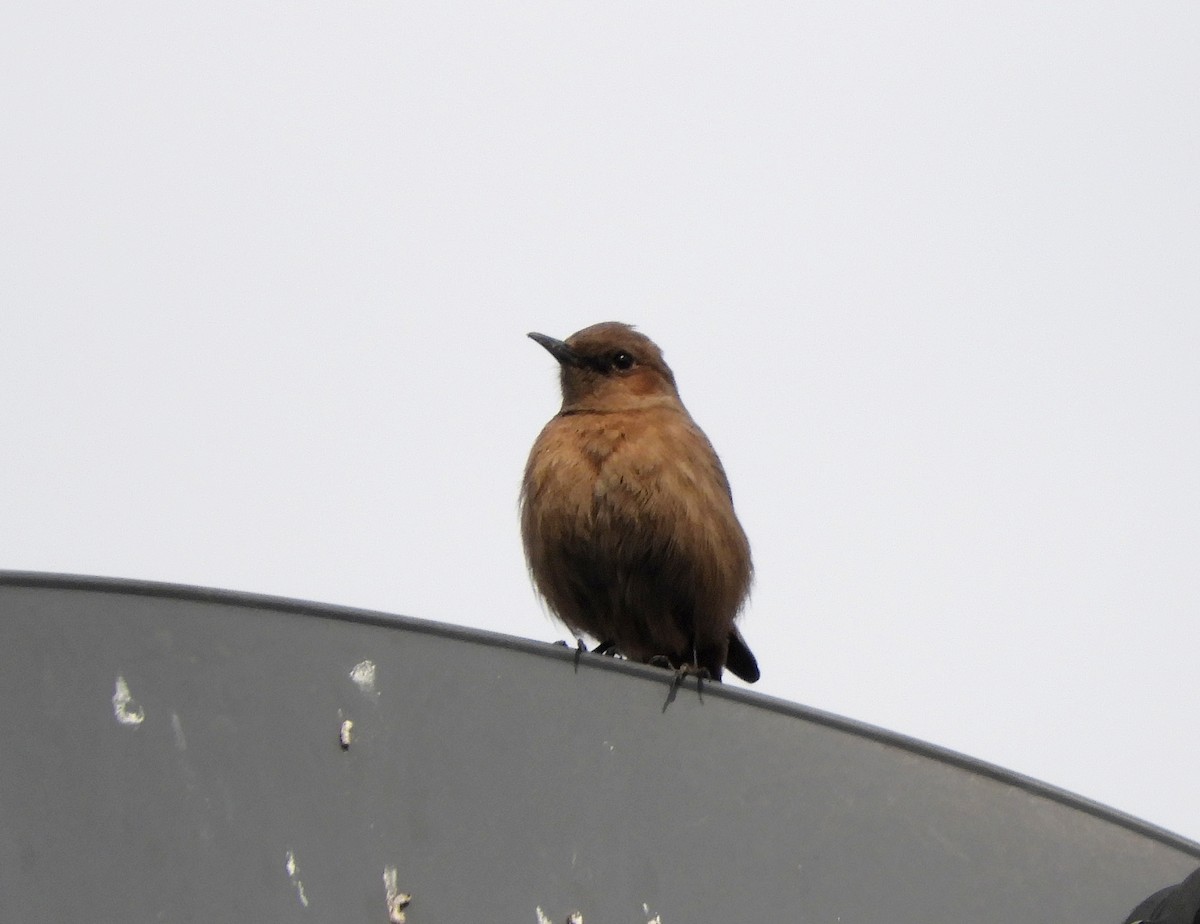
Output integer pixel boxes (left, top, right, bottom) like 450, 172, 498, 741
521, 322, 758, 683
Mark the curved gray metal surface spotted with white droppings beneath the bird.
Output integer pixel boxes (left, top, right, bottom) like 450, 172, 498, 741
0, 572, 1200, 924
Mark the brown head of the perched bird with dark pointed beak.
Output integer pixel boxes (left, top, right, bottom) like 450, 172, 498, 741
529, 320, 679, 412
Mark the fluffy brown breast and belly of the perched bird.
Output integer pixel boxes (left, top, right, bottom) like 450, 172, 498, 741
522, 407, 750, 658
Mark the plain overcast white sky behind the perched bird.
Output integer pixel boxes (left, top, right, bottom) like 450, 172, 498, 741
0, 0, 1200, 839
